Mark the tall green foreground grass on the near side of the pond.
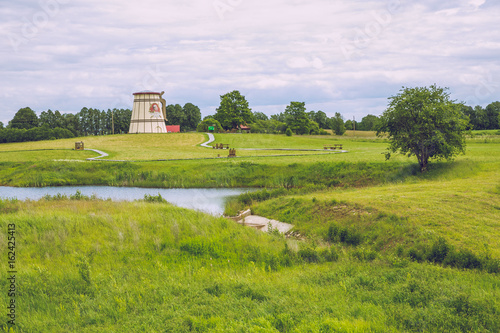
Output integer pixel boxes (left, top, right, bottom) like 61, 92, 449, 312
0, 198, 500, 332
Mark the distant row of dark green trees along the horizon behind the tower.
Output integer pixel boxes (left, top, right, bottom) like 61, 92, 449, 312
0, 90, 500, 143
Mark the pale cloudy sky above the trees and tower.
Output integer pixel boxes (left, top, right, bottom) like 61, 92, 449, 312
0, 0, 500, 125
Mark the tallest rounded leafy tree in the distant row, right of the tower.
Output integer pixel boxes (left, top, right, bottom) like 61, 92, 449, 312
214, 90, 254, 130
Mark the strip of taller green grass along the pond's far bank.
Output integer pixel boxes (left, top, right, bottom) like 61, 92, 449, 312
0, 159, 416, 188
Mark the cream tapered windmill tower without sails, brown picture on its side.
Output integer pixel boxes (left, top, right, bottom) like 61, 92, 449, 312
129, 91, 167, 133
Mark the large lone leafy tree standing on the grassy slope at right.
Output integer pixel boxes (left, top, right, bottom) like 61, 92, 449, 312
377, 85, 468, 172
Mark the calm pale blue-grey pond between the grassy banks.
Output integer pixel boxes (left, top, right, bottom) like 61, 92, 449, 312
0, 186, 252, 215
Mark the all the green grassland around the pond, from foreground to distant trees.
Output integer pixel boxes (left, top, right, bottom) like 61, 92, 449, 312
0, 131, 500, 332
